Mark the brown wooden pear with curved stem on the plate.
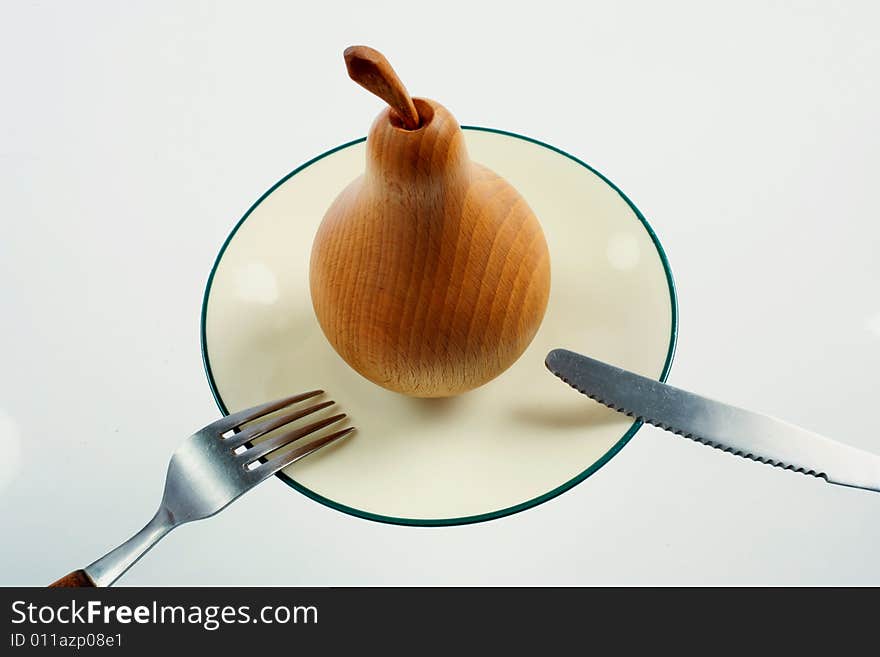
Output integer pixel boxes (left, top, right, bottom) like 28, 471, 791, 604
310, 46, 550, 397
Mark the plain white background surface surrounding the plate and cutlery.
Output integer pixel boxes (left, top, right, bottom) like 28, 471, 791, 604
0, 1, 880, 585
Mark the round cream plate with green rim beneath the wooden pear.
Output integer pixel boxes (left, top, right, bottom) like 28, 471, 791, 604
202, 128, 676, 524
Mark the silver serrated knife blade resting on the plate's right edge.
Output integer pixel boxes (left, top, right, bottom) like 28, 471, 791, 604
544, 349, 880, 492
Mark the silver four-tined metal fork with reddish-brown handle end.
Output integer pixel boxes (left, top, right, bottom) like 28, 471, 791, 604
50, 390, 354, 587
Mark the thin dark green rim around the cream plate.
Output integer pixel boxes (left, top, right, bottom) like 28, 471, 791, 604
199, 126, 678, 527
